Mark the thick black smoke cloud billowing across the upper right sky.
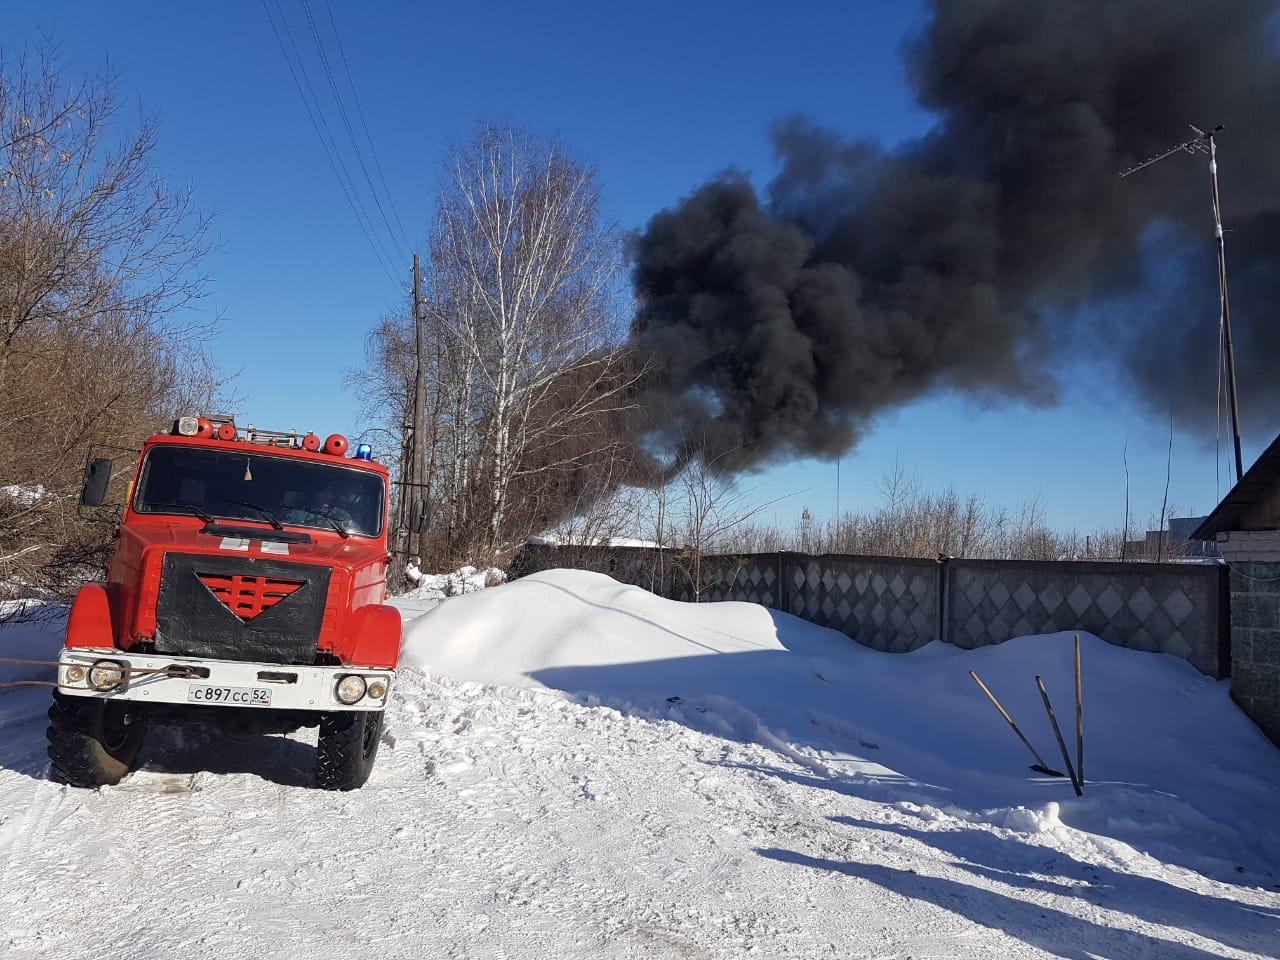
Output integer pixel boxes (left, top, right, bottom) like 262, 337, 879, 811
632, 0, 1280, 465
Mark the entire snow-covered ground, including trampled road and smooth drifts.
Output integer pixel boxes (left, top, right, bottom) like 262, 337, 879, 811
0, 571, 1280, 960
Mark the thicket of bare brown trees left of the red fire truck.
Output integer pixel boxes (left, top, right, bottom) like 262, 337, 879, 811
0, 54, 218, 604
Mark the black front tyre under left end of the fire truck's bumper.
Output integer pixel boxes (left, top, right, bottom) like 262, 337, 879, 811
47, 692, 146, 787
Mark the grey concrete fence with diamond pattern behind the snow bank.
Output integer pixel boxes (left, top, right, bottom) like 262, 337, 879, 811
512, 547, 1230, 677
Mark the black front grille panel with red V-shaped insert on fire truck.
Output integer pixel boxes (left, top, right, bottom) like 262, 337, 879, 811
155, 553, 332, 663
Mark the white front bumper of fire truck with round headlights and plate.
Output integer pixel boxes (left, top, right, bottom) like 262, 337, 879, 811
58, 648, 396, 712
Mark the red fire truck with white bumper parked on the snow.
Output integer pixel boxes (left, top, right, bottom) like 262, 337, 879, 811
49, 417, 401, 790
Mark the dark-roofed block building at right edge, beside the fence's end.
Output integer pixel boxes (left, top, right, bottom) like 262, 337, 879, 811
1192, 436, 1280, 744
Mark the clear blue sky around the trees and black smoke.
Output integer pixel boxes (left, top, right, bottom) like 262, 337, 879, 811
4, 0, 1271, 530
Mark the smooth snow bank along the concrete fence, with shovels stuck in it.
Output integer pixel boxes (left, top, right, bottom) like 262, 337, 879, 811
406, 570, 1280, 877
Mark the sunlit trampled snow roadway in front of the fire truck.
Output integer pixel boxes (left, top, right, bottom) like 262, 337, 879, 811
0, 671, 1280, 960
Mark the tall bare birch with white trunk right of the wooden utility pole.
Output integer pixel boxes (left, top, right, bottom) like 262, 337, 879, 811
429, 124, 640, 552
